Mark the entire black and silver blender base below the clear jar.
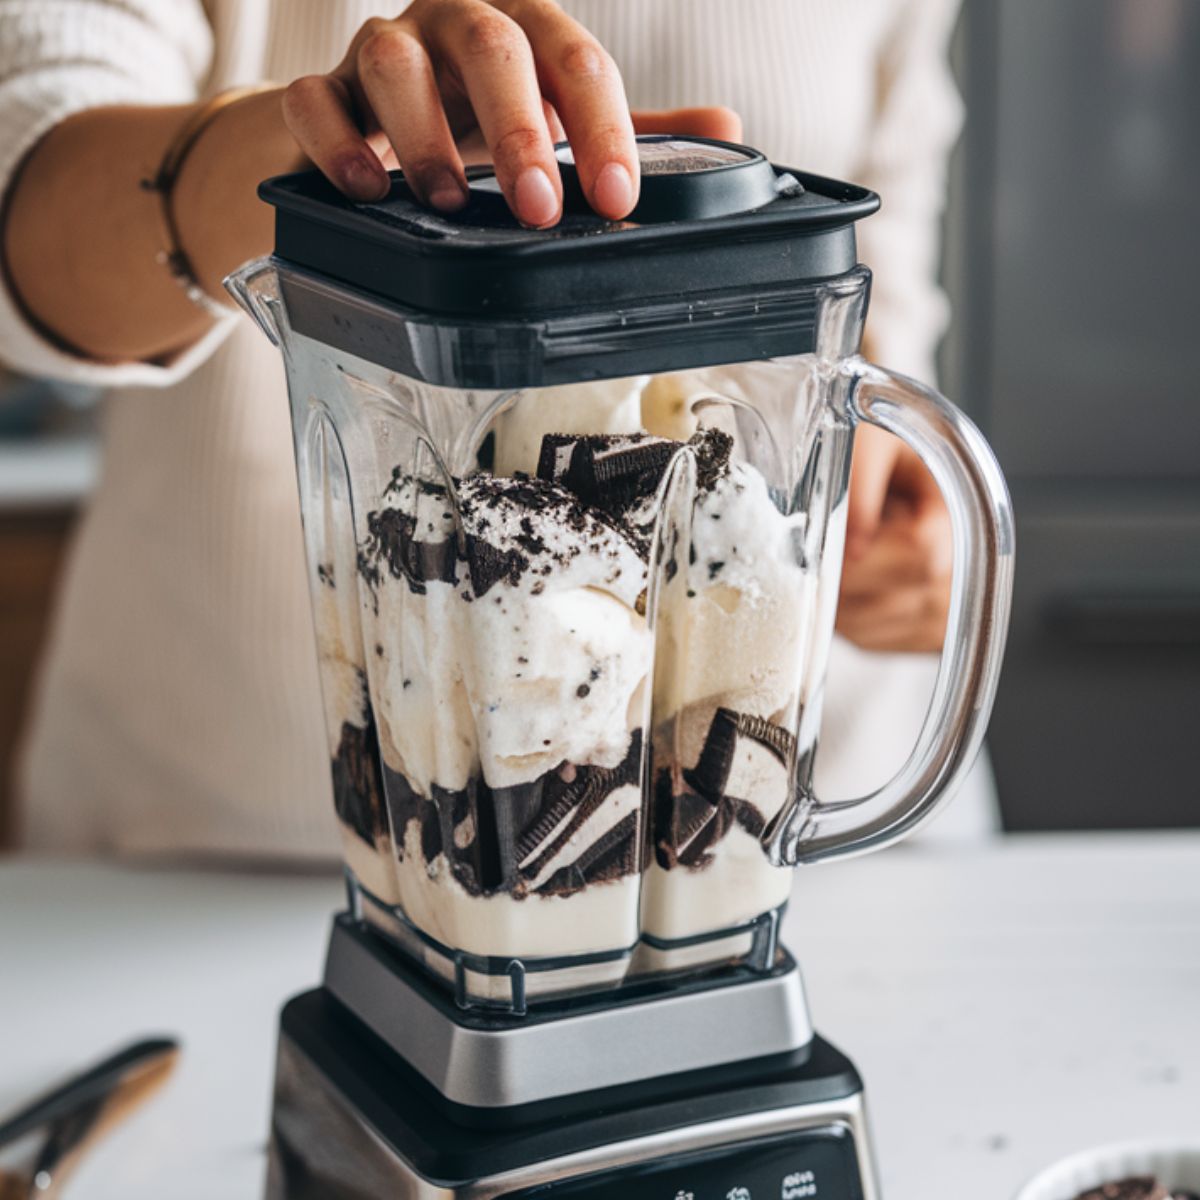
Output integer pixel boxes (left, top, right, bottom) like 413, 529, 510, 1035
266, 917, 878, 1200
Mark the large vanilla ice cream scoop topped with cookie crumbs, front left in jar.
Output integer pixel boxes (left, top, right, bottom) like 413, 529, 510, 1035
364, 458, 652, 796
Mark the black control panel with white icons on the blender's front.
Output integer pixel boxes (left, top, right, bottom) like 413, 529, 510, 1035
503, 1128, 863, 1200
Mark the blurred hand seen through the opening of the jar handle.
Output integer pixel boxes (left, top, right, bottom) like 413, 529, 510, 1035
838, 426, 952, 650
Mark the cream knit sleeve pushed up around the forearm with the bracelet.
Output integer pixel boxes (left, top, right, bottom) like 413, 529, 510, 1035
0, 0, 233, 386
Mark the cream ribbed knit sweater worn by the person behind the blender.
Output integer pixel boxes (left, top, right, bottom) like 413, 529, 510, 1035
0, 0, 979, 858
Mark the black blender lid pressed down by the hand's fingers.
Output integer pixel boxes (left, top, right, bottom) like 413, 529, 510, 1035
259, 134, 880, 319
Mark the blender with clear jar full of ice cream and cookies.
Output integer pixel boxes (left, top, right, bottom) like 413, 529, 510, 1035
228, 136, 1013, 1200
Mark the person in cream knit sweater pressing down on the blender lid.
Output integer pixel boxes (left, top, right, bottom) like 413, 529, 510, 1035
0, 0, 984, 859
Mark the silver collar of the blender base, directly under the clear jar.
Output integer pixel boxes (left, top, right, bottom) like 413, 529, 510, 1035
325, 916, 812, 1108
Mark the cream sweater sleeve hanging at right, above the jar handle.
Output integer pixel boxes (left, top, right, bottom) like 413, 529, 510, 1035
859, 0, 962, 383
